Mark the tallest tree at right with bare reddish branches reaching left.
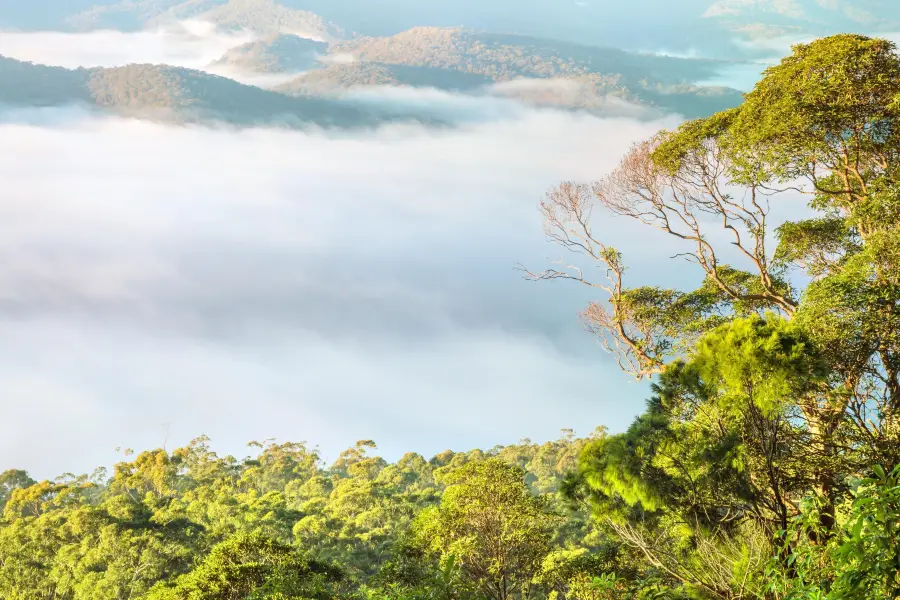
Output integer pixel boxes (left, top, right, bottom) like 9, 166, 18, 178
528, 35, 900, 526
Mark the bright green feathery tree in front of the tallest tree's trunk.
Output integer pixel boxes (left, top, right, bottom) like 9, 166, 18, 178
566, 315, 823, 599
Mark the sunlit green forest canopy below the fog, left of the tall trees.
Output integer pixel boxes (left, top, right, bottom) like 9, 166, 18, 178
0, 429, 626, 600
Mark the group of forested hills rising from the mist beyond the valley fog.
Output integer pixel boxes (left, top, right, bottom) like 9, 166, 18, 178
0, 28, 741, 127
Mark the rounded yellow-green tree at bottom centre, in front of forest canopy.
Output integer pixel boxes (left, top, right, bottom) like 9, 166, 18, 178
415, 458, 556, 600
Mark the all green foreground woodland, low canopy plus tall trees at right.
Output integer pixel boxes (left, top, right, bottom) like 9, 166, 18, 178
0, 35, 900, 600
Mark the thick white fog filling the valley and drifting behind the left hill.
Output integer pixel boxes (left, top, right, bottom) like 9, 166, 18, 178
0, 17, 820, 477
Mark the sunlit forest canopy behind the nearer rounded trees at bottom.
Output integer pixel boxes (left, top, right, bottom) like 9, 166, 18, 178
0, 430, 609, 600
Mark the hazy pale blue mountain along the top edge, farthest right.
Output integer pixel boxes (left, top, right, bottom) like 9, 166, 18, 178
281, 0, 900, 59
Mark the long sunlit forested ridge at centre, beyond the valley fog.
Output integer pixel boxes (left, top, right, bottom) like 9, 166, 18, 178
279, 27, 741, 116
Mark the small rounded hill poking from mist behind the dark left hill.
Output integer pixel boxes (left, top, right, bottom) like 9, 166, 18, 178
212, 34, 328, 73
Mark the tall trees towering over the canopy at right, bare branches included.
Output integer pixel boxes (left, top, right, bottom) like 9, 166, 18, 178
528, 35, 900, 597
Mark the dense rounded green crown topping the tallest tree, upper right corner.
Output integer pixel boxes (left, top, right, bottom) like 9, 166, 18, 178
727, 34, 900, 181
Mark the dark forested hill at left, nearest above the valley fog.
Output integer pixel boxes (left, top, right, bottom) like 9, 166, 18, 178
0, 57, 399, 127
